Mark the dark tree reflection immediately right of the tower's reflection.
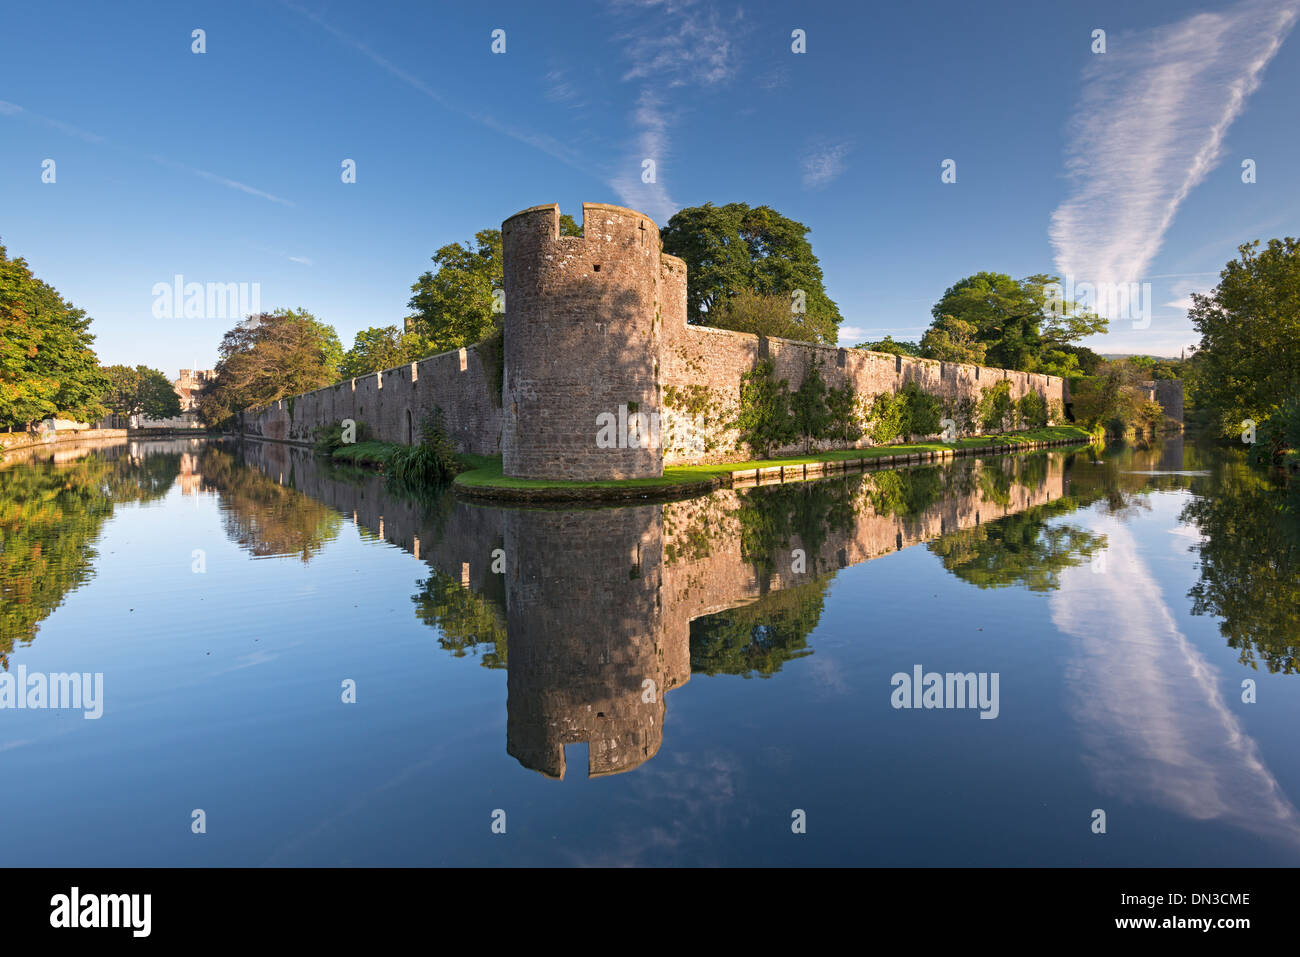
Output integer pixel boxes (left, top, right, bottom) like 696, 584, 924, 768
690, 579, 831, 677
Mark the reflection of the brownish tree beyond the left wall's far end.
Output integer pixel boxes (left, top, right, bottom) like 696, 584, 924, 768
199, 446, 343, 563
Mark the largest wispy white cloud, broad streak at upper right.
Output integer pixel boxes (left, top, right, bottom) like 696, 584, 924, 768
1050, 0, 1300, 293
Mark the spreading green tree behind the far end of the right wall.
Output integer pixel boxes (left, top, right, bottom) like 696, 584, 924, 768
922, 272, 1109, 374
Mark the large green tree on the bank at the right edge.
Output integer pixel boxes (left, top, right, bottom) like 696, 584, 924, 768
1187, 237, 1300, 436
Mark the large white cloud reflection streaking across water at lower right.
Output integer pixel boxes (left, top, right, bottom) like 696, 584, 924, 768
1052, 515, 1300, 845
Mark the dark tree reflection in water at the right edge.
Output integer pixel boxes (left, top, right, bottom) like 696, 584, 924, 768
1180, 456, 1300, 675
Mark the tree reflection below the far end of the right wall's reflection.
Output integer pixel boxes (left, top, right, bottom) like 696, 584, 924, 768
927, 497, 1106, 592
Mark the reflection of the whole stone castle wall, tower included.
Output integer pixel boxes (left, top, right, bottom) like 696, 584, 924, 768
244, 442, 1066, 778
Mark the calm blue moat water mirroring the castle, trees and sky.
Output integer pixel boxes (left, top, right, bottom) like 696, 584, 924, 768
0, 436, 1300, 866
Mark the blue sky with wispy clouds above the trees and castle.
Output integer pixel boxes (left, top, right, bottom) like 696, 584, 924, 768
0, 0, 1300, 376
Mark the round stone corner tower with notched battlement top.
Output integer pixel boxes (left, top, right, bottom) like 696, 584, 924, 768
501, 203, 663, 480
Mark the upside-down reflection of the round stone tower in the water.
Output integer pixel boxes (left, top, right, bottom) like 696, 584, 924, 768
506, 506, 690, 778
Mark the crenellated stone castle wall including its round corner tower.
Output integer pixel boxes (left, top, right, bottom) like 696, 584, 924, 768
239, 203, 1067, 480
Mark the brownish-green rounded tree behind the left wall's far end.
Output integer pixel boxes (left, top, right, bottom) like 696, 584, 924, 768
199, 309, 342, 425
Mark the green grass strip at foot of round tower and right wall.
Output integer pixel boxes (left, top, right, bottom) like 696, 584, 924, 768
452, 425, 1092, 489
